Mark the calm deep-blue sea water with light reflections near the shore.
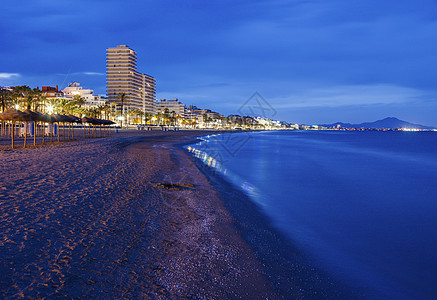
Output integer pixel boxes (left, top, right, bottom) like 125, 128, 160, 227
189, 131, 437, 299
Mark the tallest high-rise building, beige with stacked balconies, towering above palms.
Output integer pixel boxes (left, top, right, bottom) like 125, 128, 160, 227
106, 45, 156, 113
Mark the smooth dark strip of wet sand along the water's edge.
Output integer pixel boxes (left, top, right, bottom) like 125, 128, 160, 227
179, 132, 358, 299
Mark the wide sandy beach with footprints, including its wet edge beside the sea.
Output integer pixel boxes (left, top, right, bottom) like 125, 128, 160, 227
0, 131, 352, 299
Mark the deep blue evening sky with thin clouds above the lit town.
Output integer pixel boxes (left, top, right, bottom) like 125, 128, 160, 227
0, 0, 437, 126
